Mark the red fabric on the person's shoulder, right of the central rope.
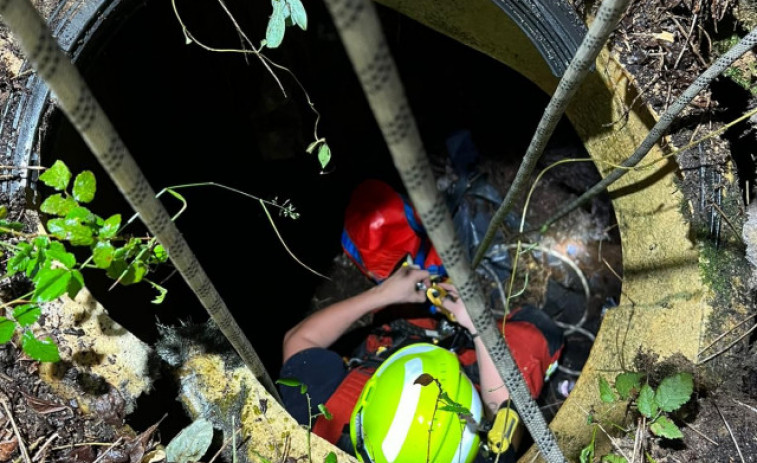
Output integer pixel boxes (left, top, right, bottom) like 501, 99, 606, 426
497, 314, 562, 398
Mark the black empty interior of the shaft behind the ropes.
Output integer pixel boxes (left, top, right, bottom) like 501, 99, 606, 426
37, 0, 620, 444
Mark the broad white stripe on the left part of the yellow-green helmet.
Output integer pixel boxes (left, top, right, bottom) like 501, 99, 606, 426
381, 358, 423, 463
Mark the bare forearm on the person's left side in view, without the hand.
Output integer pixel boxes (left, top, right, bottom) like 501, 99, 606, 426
283, 286, 392, 362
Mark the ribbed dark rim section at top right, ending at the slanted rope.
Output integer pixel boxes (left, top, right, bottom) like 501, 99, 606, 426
492, 0, 586, 77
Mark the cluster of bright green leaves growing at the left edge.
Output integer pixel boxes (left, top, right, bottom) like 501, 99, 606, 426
0, 161, 168, 362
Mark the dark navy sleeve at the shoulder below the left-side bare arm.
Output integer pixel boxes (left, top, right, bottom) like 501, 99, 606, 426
279, 347, 347, 425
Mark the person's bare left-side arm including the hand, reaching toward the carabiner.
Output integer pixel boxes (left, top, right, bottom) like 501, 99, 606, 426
283, 267, 429, 362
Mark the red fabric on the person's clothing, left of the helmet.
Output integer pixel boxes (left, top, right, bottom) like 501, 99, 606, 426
313, 367, 374, 444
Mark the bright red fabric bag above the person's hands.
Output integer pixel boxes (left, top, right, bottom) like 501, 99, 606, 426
344, 180, 441, 281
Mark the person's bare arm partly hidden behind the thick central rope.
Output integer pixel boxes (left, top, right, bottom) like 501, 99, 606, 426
440, 283, 510, 416
